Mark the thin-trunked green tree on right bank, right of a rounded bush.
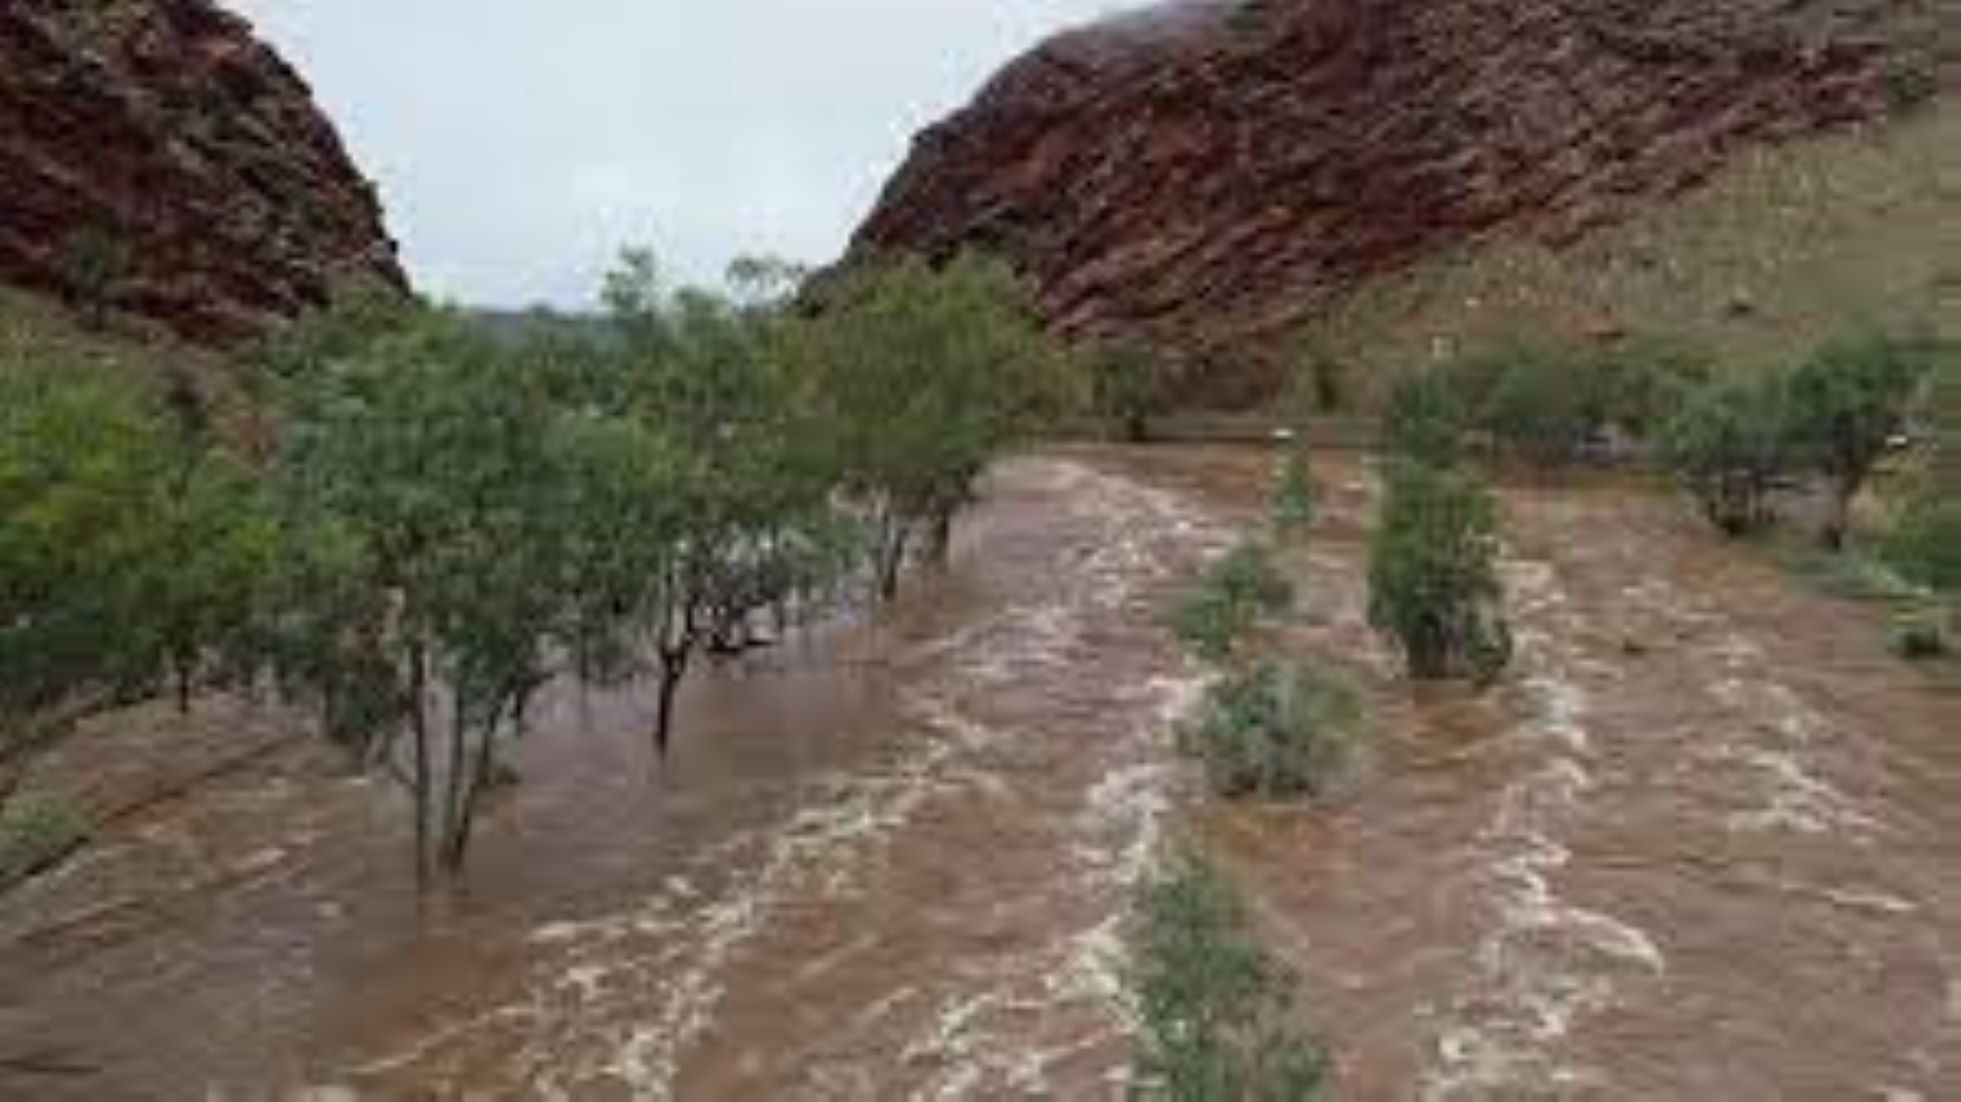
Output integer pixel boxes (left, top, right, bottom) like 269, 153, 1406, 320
1785, 331, 1937, 551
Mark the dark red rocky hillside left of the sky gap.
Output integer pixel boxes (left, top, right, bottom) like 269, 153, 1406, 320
0, 0, 406, 341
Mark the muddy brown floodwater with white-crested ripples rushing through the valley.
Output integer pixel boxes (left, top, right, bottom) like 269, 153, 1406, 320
0, 441, 1961, 1100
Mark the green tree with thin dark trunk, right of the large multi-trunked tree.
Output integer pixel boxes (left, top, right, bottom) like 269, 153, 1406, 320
578, 255, 859, 751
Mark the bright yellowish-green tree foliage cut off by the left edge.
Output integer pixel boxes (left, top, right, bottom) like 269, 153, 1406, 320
0, 359, 269, 716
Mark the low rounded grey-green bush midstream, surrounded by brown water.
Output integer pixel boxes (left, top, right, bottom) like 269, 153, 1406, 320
1186, 663, 1361, 800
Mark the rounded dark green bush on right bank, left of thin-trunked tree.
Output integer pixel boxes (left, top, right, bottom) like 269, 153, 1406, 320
1659, 378, 1792, 535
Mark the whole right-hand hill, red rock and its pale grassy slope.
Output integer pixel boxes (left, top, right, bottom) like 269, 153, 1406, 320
855, 0, 1961, 408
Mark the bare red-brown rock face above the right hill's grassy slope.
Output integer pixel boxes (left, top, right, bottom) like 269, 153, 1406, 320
855, 0, 1937, 406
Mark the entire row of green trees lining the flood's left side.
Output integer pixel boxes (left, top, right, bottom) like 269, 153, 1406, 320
0, 253, 1069, 871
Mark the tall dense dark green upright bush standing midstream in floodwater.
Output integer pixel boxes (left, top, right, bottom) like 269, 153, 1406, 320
1369, 461, 1512, 684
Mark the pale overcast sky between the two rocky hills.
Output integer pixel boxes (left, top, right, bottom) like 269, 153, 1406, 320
227, 0, 1124, 306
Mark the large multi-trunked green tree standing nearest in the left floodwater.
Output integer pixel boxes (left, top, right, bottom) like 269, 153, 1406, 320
262, 300, 567, 873
